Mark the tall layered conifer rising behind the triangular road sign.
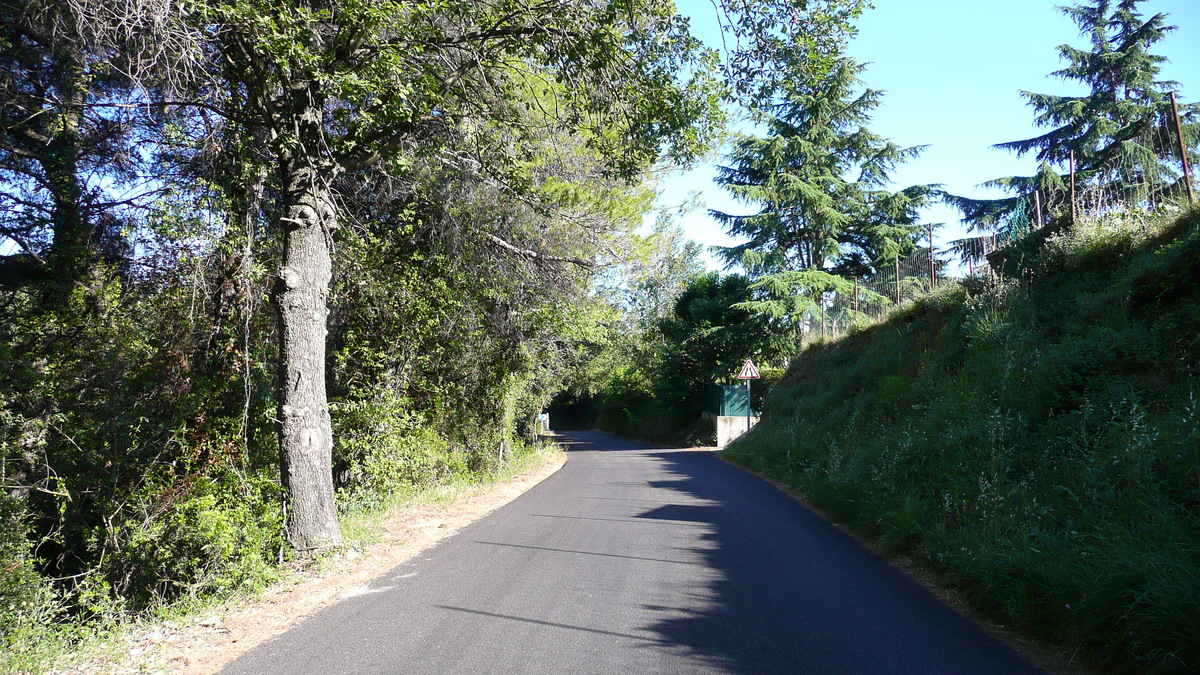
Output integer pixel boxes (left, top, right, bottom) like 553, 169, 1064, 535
710, 58, 937, 331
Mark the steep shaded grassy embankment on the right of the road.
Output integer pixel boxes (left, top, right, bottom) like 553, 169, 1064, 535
726, 209, 1200, 673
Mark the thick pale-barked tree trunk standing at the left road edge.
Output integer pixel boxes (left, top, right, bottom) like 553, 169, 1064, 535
275, 157, 342, 554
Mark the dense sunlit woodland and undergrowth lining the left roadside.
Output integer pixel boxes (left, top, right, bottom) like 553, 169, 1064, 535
0, 0, 862, 668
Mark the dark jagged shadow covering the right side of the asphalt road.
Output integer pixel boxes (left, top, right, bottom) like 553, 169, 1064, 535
636, 450, 1038, 675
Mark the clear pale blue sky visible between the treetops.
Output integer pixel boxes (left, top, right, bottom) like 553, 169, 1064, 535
659, 0, 1200, 268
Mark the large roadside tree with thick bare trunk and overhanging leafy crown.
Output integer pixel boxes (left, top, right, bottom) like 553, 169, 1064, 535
194, 0, 714, 551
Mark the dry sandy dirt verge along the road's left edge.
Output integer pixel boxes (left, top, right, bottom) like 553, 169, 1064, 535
58, 454, 566, 675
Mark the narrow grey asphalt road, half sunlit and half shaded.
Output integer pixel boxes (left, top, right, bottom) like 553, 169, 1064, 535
226, 432, 1038, 675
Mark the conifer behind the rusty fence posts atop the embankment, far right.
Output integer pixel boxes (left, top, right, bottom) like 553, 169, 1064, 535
949, 0, 1200, 227
